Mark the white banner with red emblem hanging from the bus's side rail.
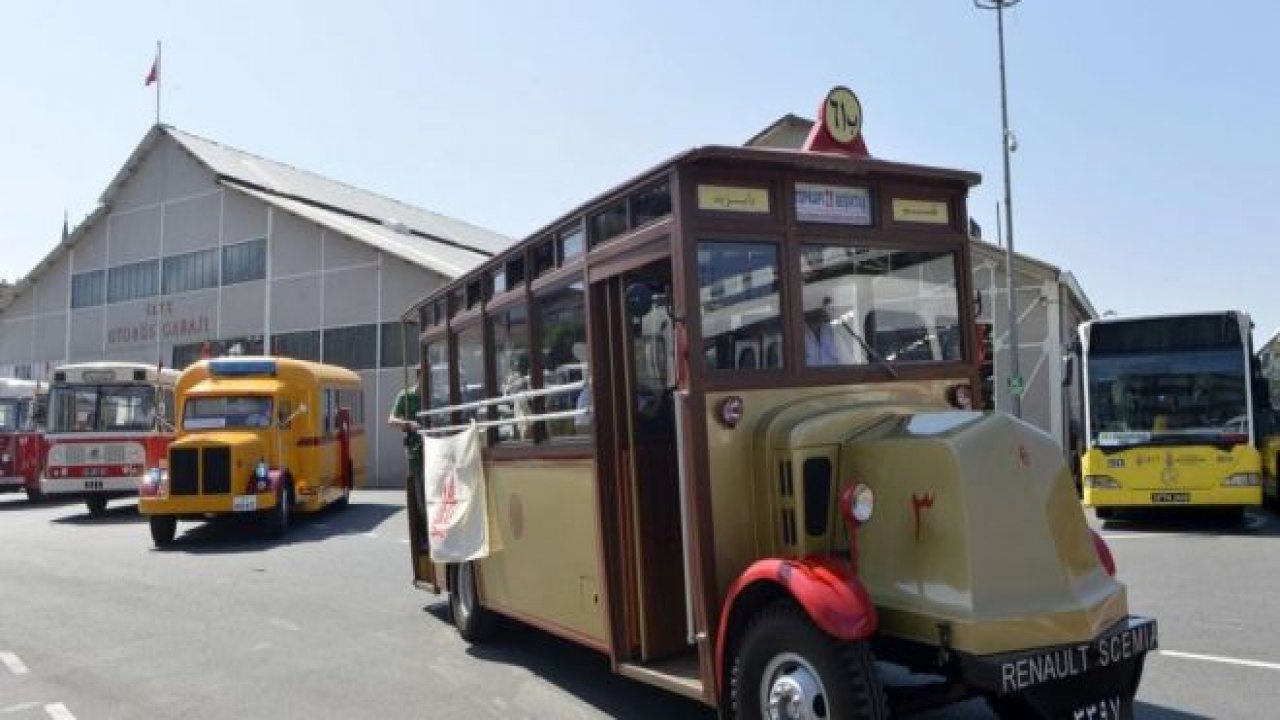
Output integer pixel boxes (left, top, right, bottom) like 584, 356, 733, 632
422, 421, 489, 562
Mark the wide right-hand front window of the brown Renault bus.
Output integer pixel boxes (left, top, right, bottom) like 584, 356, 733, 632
800, 245, 961, 366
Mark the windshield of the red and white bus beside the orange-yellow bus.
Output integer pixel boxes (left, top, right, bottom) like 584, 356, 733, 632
49, 384, 156, 433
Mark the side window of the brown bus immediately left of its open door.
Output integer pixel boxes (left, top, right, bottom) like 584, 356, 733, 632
538, 282, 590, 438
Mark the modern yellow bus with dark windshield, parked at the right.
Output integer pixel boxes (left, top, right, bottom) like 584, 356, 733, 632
1079, 311, 1270, 518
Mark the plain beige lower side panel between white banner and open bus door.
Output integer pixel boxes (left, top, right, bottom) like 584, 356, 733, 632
480, 459, 608, 647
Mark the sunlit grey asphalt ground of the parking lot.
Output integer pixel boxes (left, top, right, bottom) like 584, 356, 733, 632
0, 491, 1280, 720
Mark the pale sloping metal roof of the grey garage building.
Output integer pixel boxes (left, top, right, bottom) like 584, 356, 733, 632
161, 126, 512, 258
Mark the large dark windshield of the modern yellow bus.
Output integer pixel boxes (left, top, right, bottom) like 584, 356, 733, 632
1089, 348, 1249, 447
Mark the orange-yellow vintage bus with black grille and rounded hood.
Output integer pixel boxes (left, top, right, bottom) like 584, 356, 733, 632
138, 357, 366, 546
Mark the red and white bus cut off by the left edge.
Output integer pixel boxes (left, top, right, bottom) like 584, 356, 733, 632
0, 378, 49, 501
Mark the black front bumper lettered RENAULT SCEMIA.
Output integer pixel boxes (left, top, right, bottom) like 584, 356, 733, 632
959, 615, 1158, 717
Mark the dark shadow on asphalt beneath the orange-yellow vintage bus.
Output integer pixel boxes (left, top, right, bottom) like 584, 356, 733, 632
161, 502, 401, 555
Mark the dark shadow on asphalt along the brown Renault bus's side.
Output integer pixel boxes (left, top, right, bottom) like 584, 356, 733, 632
422, 596, 716, 720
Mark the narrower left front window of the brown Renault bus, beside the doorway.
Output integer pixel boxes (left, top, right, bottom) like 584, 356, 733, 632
698, 242, 782, 370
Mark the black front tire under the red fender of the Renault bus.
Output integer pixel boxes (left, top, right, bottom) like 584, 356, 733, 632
730, 601, 890, 720
